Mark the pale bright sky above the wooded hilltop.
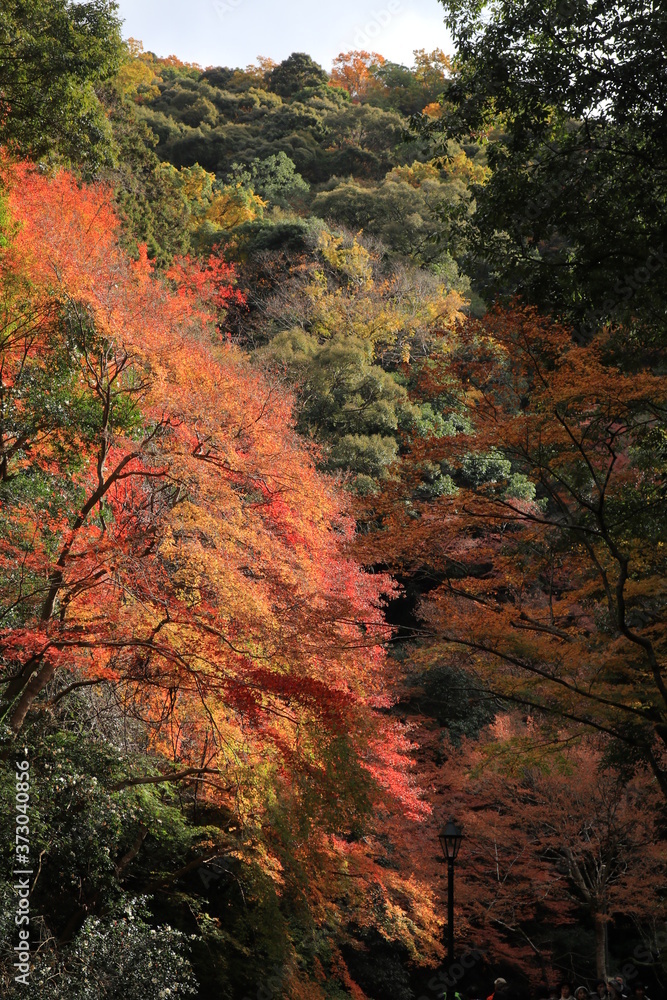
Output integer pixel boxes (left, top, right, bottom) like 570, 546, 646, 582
113, 0, 452, 70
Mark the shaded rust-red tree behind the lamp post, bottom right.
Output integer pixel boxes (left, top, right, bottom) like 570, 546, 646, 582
416, 713, 667, 993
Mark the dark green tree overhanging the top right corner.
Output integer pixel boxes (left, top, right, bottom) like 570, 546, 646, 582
434, 0, 667, 348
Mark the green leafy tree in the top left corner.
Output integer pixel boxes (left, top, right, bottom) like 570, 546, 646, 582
0, 0, 124, 170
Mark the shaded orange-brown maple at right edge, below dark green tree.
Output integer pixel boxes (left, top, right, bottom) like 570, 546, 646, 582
365, 305, 667, 793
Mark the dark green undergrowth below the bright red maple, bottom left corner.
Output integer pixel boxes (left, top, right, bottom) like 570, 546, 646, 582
0, 704, 320, 1000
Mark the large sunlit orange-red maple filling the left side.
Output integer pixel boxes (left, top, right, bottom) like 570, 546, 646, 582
0, 166, 444, 992
